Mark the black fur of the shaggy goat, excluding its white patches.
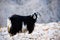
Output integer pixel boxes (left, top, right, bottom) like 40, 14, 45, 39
9, 13, 37, 35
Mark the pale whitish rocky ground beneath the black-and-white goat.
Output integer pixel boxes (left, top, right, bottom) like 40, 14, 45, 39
0, 22, 60, 40
